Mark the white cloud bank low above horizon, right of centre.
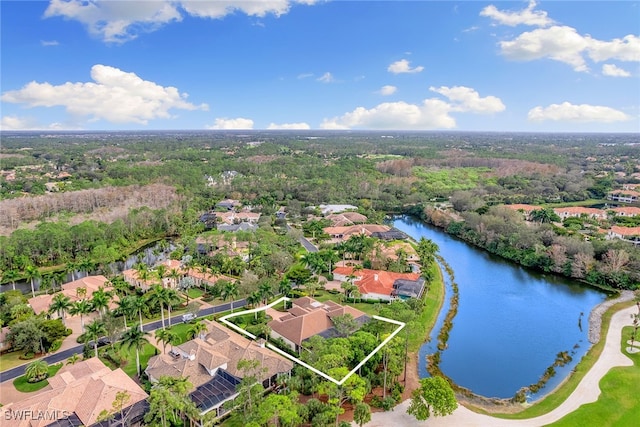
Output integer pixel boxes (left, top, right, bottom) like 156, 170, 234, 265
320, 86, 505, 130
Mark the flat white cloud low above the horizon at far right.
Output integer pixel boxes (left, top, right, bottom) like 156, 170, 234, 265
527, 102, 630, 123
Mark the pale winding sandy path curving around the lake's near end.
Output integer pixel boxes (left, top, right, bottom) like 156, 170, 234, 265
365, 306, 638, 427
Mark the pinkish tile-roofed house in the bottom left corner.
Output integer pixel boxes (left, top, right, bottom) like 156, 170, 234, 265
0, 357, 148, 427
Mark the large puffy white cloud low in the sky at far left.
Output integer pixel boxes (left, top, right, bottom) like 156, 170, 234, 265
0, 64, 208, 124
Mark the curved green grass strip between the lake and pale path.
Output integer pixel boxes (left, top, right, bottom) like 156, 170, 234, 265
482, 301, 638, 425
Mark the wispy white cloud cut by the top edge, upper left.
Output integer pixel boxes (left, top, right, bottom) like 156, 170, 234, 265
44, 0, 316, 43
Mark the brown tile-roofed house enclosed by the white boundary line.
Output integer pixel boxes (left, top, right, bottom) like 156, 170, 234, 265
267, 297, 369, 352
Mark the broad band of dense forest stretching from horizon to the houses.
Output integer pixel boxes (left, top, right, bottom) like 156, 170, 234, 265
0, 131, 640, 288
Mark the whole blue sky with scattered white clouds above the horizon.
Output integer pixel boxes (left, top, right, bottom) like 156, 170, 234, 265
0, 0, 640, 132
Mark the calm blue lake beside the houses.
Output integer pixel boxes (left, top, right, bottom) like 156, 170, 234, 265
393, 217, 606, 400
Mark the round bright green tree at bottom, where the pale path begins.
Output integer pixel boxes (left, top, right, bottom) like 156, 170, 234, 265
407, 377, 458, 421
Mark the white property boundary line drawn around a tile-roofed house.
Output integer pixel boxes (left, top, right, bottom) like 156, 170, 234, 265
220, 297, 406, 385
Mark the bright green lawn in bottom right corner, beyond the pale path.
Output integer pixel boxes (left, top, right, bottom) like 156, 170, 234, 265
550, 326, 640, 427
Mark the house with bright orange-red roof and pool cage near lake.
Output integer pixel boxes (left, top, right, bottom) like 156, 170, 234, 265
333, 267, 425, 301
